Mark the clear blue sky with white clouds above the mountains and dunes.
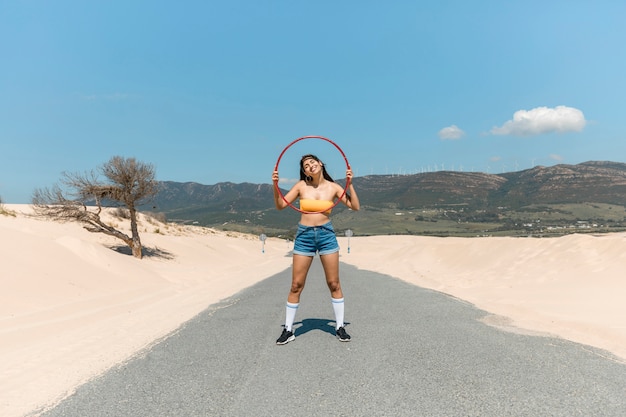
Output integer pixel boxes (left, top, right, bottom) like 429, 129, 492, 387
0, 0, 626, 203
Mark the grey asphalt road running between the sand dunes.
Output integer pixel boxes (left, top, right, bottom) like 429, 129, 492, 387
44, 258, 626, 417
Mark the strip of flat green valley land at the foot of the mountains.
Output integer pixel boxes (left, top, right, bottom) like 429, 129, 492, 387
203, 203, 626, 239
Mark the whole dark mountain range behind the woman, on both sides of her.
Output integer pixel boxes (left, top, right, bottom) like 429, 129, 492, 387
144, 161, 626, 235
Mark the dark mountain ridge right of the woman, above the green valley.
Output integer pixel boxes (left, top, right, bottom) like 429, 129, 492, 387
355, 162, 626, 209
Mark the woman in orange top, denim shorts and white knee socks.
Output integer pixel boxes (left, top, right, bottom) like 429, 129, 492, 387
272, 155, 360, 345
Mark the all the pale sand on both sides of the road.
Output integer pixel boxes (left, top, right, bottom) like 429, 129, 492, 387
0, 205, 626, 417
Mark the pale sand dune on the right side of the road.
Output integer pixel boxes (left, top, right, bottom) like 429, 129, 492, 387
342, 234, 626, 359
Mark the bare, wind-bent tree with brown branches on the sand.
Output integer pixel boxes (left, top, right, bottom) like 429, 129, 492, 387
33, 156, 158, 259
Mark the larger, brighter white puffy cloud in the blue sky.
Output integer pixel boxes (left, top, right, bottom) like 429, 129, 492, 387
491, 106, 587, 136
